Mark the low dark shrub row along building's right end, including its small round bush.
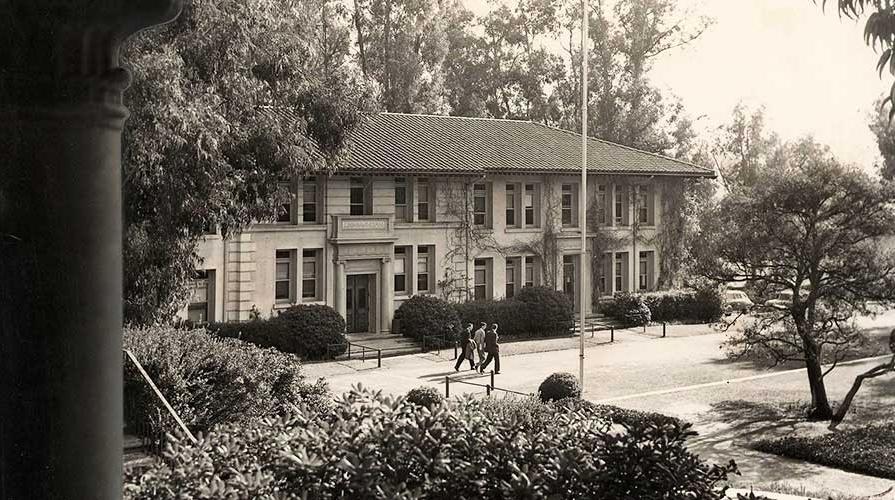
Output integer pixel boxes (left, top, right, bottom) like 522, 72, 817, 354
600, 287, 723, 326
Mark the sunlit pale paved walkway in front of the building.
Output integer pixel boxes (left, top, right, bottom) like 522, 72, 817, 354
306, 313, 895, 495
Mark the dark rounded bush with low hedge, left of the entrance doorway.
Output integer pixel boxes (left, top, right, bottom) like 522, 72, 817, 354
208, 304, 348, 359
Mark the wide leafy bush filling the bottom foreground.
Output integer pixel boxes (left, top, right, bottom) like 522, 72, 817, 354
124, 390, 735, 500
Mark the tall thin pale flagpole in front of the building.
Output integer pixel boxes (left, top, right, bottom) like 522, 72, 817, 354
578, 0, 590, 391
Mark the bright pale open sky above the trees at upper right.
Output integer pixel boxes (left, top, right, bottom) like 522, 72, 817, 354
652, 0, 892, 170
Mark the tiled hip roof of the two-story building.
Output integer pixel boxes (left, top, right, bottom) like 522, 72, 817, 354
341, 113, 715, 177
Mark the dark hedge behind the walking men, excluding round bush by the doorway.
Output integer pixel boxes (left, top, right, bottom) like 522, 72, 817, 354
453, 287, 575, 339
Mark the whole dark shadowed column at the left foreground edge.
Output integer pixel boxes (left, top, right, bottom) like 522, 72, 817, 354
0, 0, 179, 500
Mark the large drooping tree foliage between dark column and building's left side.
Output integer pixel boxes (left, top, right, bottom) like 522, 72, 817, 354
122, 0, 373, 324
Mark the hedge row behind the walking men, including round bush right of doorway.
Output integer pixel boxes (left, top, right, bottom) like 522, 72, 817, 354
395, 287, 575, 339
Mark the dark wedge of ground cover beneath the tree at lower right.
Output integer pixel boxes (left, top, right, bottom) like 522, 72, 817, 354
753, 422, 895, 479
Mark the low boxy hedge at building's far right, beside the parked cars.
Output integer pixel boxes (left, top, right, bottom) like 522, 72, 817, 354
643, 287, 722, 323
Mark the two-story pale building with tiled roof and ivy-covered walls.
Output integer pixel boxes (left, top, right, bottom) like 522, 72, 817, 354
184, 113, 714, 333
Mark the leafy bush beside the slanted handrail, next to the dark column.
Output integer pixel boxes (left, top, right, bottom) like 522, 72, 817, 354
123, 327, 329, 434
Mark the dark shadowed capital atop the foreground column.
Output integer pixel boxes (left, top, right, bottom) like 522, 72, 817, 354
0, 0, 181, 113
